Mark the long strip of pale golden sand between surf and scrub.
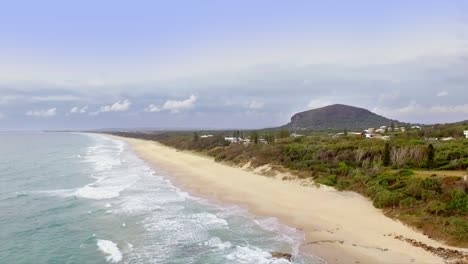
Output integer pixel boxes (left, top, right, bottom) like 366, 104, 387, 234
114, 137, 468, 263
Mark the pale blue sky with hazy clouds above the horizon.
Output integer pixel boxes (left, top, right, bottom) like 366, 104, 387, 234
0, 0, 468, 130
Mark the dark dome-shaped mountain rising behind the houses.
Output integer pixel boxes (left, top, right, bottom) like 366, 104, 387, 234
284, 104, 402, 131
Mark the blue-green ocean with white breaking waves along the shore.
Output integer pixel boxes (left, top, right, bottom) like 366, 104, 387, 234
0, 133, 323, 264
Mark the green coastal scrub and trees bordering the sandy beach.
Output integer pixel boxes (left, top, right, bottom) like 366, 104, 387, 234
110, 126, 468, 246
